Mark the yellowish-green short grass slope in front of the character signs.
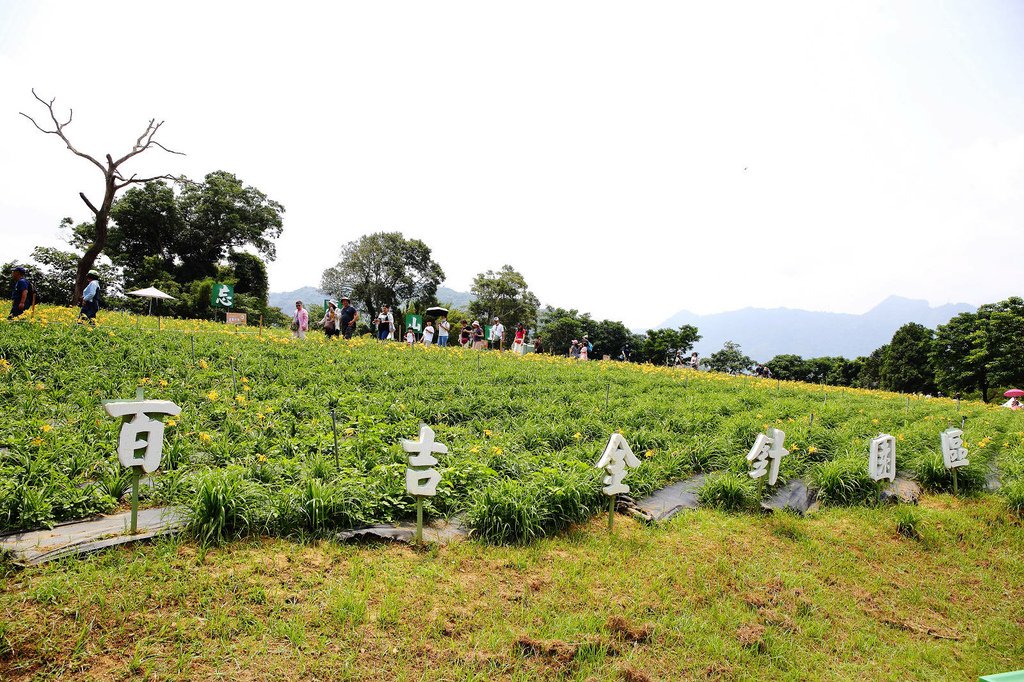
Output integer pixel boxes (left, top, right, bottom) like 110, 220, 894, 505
0, 495, 1024, 680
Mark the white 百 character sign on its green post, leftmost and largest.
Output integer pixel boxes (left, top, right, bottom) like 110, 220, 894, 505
103, 388, 181, 535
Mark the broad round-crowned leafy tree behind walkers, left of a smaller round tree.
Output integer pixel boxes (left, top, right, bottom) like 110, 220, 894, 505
321, 232, 444, 315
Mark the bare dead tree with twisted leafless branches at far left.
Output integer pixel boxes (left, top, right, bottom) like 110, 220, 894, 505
19, 88, 184, 301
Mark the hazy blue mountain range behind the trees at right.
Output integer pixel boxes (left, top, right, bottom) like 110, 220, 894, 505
658, 296, 977, 363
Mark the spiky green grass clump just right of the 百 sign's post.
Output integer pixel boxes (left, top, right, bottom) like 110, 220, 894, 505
187, 467, 267, 545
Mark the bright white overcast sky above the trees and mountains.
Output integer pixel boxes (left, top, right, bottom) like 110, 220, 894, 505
0, 0, 1024, 327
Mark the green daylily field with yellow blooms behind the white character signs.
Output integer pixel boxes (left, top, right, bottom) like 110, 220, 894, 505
0, 307, 1024, 544
